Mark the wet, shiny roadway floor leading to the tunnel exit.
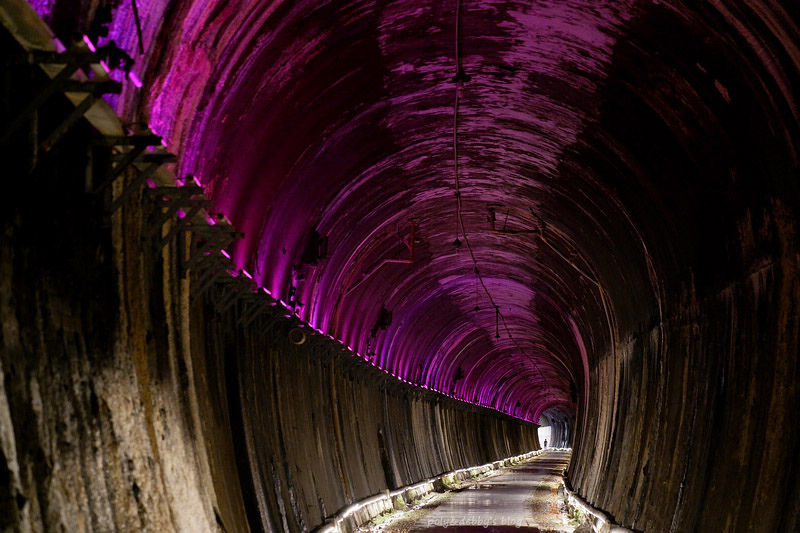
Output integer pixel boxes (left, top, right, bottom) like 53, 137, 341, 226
370, 451, 574, 533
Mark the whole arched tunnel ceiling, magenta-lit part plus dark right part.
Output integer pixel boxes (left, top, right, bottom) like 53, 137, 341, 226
36, 0, 798, 421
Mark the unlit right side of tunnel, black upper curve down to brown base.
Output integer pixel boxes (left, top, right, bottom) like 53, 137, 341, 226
564, 2, 800, 532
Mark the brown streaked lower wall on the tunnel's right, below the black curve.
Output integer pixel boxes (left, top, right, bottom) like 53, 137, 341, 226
569, 196, 800, 531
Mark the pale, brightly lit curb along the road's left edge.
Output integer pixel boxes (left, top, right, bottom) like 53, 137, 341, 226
316, 448, 558, 533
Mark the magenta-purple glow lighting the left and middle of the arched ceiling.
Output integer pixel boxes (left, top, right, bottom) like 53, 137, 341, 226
72, 0, 632, 418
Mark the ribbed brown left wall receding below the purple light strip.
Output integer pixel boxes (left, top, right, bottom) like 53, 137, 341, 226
203, 296, 540, 531
